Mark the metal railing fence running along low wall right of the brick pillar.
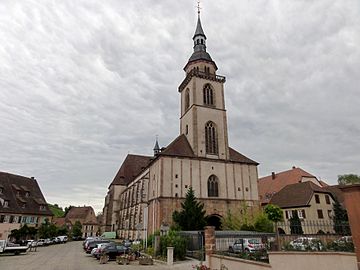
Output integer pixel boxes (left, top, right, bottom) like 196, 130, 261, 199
215, 220, 354, 262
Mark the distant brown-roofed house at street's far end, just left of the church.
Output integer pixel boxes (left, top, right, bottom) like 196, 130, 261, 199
64, 206, 100, 238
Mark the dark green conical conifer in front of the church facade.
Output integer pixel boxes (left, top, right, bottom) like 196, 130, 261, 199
172, 187, 206, 231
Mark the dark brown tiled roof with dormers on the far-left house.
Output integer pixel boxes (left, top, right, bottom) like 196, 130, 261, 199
0, 172, 53, 216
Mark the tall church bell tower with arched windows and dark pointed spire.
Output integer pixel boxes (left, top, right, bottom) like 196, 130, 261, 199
179, 11, 229, 160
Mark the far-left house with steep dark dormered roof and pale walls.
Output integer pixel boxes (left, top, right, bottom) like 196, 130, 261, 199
0, 172, 53, 239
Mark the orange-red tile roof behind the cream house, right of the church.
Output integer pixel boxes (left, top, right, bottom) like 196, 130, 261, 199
258, 167, 317, 204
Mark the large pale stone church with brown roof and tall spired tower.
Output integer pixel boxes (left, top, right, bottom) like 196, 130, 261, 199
103, 13, 259, 239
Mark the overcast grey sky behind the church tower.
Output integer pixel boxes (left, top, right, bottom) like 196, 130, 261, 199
0, 0, 360, 212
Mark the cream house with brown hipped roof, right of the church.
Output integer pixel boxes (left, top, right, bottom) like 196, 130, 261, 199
269, 181, 341, 234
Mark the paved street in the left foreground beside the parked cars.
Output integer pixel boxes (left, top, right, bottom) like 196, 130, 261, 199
0, 242, 197, 270
